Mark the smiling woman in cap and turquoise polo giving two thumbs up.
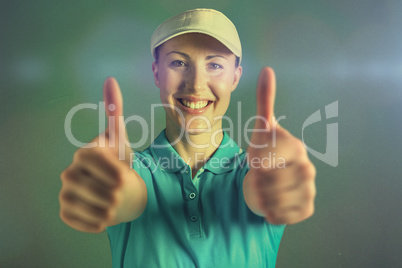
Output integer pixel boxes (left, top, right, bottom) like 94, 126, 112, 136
60, 9, 315, 267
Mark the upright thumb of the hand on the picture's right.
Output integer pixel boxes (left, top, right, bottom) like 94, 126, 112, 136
257, 67, 276, 127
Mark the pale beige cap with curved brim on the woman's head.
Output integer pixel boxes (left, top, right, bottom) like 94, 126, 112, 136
151, 8, 241, 63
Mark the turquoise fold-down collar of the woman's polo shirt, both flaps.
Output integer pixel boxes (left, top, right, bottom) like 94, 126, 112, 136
150, 130, 243, 174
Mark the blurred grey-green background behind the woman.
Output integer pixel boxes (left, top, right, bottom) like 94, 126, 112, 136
0, 0, 402, 267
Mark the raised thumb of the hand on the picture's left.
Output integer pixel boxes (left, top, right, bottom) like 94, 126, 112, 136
103, 77, 131, 159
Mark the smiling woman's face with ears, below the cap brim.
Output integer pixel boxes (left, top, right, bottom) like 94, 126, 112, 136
152, 33, 242, 135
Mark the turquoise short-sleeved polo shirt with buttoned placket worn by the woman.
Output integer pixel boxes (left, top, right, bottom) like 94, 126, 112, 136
106, 131, 285, 268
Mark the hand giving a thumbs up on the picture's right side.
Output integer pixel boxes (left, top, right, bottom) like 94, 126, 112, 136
243, 67, 316, 224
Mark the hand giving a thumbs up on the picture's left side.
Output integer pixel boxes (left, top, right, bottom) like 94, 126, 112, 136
59, 78, 147, 233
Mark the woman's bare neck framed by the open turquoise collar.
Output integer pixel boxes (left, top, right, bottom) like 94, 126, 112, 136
166, 123, 223, 177
